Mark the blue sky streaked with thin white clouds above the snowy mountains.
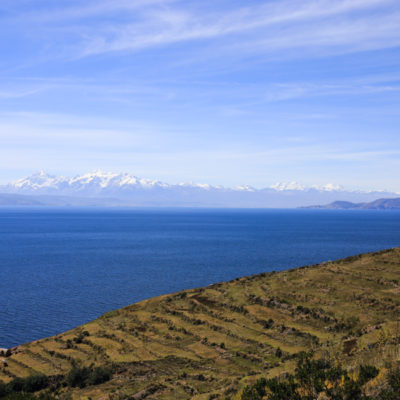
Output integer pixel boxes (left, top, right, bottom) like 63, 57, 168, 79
0, 0, 400, 192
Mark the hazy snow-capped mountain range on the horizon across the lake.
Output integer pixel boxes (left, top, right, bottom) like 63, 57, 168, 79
0, 171, 397, 207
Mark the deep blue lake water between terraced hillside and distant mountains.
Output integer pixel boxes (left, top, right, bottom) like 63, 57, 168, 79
0, 208, 400, 347
